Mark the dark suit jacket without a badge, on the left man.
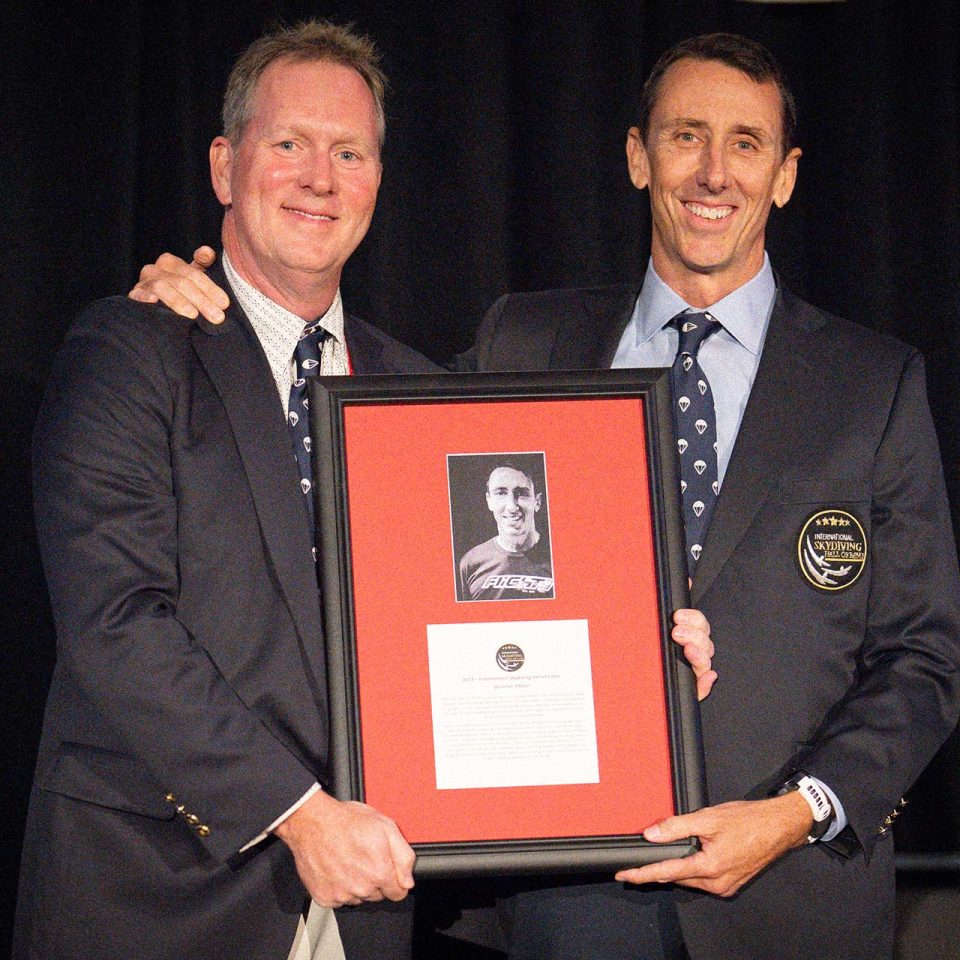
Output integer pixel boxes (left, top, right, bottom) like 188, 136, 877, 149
15, 262, 436, 960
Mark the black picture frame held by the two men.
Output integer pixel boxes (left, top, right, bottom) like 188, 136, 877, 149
309, 369, 707, 877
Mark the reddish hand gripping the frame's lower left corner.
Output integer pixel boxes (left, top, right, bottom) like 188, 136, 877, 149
274, 790, 416, 907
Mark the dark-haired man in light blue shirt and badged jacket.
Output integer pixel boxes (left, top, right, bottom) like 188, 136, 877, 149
467, 34, 960, 960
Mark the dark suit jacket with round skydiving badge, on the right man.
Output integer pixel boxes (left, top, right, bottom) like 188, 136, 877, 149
468, 287, 960, 960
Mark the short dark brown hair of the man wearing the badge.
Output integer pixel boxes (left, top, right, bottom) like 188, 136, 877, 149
637, 33, 797, 157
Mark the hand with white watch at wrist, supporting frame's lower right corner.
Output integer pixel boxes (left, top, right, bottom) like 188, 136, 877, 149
616, 791, 813, 897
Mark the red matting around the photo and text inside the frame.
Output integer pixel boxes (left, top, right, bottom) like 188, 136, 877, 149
344, 398, 674, 843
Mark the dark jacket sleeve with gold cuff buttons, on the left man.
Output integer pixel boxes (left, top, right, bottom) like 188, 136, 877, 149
34, 301, 315, 860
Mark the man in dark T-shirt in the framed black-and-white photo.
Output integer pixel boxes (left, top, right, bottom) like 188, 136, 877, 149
459, 461, 553, 600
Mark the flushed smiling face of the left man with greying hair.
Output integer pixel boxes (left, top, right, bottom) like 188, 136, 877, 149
210, 60, 381, 317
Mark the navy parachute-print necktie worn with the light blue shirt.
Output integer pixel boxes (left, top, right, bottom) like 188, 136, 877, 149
670, 313, 720, 577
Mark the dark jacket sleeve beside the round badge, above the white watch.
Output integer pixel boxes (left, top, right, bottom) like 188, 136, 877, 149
797, 354, 960, 855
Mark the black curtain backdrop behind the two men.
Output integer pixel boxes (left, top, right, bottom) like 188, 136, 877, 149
0, 0, 960, 949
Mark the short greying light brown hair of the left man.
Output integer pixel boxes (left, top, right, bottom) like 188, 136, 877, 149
222, 20, 387, 148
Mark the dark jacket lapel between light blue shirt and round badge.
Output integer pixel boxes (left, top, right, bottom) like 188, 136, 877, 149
691, 291, 815, 604
